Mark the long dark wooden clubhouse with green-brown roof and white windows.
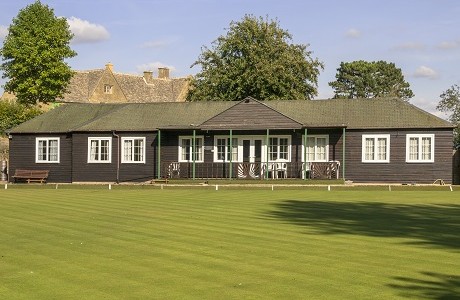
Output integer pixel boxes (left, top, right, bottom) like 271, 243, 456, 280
9, 98, 453, 183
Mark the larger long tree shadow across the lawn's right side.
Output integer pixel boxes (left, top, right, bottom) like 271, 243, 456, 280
268, 200, 460, 250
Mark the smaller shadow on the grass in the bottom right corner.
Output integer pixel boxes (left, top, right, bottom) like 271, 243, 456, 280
389, 272, 460, 300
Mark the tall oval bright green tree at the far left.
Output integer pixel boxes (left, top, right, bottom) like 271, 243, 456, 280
0, 1, 76, 105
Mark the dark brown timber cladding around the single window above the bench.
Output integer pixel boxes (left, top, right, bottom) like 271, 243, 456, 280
9, 134, 72, 182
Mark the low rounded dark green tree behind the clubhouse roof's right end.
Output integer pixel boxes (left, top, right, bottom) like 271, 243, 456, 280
329, 60, 414, 101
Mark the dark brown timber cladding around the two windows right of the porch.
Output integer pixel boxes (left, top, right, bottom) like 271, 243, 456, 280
345, 129, 452, 183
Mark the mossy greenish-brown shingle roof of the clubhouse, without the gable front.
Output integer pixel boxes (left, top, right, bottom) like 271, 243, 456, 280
11, 98, 453, 133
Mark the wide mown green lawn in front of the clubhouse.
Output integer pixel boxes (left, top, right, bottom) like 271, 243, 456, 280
0, 187, 460, 299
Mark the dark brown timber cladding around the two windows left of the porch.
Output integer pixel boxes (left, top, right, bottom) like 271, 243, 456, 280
73, 132, 156, 182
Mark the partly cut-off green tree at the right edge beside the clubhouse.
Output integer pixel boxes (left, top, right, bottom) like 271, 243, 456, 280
436, 84, 460, 145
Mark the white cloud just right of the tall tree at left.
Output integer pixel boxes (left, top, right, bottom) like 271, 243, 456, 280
67, 17, 110, 44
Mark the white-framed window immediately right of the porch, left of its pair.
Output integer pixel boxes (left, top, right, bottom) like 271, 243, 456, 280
362, 134, 390, 163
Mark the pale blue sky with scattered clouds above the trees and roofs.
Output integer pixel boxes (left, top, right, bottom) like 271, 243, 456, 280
0, 0, 460, 117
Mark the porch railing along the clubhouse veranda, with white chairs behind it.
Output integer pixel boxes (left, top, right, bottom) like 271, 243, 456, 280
160, 161, 340, 180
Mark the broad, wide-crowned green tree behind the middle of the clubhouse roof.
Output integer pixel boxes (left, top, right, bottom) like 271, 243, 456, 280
187, 15, 323, 101
